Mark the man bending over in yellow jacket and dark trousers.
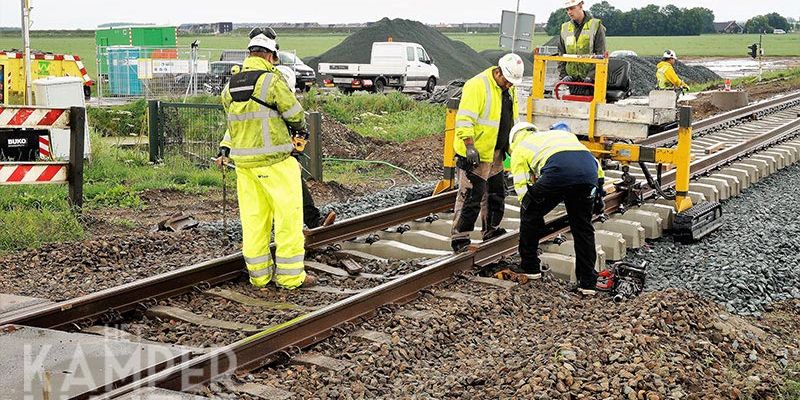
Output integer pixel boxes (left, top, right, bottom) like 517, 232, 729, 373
509, 122, 604, 292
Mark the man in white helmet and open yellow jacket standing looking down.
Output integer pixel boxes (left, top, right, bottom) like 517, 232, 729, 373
451, 53, 525, 252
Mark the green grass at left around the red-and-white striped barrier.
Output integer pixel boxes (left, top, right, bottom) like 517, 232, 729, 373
0, 134, 223, 253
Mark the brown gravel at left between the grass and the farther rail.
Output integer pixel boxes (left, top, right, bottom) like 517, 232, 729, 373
0, 229, 237, 301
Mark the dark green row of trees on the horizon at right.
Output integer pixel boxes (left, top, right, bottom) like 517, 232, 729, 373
545, 1, 792, 36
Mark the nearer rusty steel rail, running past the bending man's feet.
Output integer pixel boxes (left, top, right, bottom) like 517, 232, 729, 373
97, 118, 800, 399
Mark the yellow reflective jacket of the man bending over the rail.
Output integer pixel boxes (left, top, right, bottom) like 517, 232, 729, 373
511, 130, 605, 201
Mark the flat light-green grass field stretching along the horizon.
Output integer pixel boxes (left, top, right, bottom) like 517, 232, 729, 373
0, 33, 800, 82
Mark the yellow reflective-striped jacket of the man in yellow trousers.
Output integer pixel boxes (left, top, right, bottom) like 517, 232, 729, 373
220, 57, 305, 168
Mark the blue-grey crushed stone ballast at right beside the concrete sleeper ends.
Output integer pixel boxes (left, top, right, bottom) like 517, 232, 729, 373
632, 165, 800, 315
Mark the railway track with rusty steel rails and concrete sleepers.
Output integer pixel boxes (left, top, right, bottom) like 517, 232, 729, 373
0, 93, 800, 399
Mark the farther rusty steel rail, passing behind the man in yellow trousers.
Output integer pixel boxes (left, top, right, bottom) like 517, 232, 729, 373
0, 192, 455, 329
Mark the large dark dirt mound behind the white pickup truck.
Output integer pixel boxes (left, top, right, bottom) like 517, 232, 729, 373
306, 18, 490, 82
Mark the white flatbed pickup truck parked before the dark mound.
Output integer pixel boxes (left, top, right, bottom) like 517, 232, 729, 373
319, 42, 439, 93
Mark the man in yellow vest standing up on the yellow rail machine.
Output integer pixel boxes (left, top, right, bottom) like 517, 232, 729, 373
558, 0, 606, 95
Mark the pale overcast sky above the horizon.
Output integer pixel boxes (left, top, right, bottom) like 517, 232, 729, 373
0, 0, 800, 29
